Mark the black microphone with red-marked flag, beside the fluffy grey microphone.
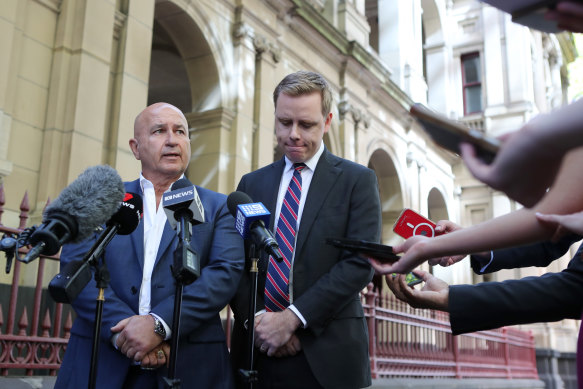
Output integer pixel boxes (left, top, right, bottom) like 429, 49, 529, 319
49, 192, 143, 304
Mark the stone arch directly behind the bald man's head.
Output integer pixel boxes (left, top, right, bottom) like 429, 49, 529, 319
148, 0, 235, 192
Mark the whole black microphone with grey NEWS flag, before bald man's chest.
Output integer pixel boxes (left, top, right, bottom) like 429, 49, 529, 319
163, 177, 204, 285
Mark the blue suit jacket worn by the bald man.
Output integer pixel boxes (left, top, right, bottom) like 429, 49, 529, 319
55, 180, 244, 389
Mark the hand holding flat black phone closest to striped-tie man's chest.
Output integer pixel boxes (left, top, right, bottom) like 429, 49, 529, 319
368, 235, 435, 274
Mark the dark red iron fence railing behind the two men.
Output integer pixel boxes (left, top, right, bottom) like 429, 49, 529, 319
0, 186, 538, 379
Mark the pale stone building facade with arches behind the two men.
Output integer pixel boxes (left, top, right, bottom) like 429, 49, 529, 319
0, 0, 576, 382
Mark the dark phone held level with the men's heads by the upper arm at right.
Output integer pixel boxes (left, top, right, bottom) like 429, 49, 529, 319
409, 104, 500, 163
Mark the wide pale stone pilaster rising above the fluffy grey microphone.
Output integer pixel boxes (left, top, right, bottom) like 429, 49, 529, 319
38, 0, 115, 203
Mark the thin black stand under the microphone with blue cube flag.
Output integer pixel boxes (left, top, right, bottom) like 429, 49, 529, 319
239, 243, 259, 389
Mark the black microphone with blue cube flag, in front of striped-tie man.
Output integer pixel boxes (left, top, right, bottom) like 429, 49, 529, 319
227, 192, 283, 262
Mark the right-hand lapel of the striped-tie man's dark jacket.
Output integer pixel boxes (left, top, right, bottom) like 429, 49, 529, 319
295, 150, 342, 259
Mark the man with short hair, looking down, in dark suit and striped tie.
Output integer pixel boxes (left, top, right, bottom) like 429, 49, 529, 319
231, 71, 381, 388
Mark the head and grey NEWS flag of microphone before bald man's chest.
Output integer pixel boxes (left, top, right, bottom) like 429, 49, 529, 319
163, 177, 204, 229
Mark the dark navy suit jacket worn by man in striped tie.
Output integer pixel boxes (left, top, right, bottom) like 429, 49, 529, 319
231, 150, 381, 388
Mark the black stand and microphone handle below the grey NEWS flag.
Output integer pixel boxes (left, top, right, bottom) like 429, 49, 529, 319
164, 209, 200, 389
